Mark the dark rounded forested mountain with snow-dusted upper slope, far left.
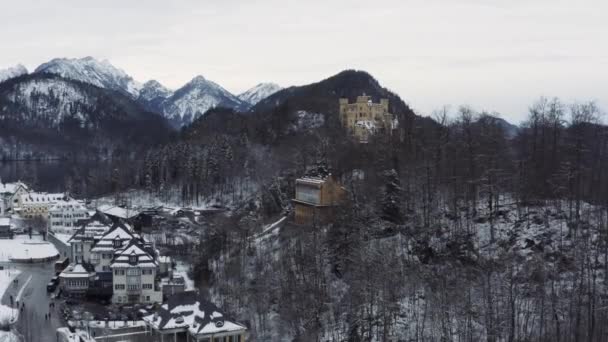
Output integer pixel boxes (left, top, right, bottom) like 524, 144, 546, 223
0, 74, 171, 160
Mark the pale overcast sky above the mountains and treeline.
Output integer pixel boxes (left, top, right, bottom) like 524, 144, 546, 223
0, 0, 608, 122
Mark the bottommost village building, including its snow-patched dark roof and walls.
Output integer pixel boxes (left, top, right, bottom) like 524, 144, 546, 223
143, 291, 247, 342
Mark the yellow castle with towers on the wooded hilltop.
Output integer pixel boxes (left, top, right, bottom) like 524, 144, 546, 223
340, 94, 397, 143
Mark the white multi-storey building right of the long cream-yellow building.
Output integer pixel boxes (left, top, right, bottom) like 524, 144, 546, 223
49, 199, 89, 234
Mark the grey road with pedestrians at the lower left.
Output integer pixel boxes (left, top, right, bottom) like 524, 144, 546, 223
2, 262, 65, 342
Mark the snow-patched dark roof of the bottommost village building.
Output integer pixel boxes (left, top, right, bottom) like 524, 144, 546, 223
144, 291, 247, 337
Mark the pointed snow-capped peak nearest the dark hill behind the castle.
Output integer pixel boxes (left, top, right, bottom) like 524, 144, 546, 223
162, 76, 248, 127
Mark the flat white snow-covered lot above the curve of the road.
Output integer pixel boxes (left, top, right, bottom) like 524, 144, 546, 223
0, 235, 59, 261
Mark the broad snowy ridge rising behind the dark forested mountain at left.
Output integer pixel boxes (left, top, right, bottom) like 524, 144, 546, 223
34, 57, 141, 98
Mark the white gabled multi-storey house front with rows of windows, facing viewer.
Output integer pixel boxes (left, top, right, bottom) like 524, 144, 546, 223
110, 240, 163, 304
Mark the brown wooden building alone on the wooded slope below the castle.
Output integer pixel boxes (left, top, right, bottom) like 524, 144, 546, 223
292, 175, 346, 225
